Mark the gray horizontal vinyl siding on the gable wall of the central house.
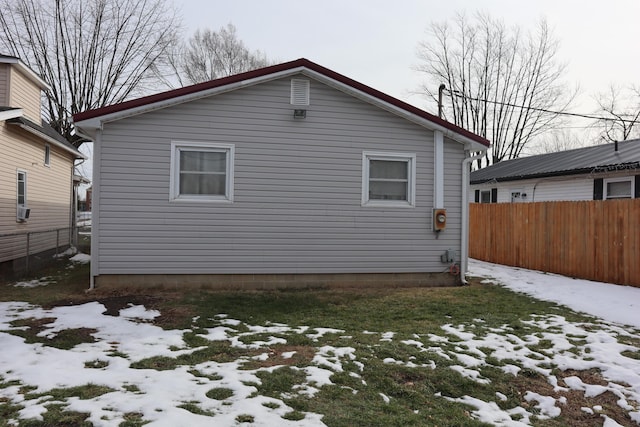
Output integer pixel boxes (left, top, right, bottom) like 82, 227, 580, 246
94, 78, 463, 274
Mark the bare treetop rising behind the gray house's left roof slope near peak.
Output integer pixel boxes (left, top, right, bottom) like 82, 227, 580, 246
158, 24, 270, 87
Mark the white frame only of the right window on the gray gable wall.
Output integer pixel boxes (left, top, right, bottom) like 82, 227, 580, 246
362, 151, 416, 208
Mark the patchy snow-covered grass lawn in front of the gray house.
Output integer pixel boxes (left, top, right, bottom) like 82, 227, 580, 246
0, 261, 640, 427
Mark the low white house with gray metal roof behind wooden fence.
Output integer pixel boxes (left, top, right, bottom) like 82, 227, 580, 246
470, 140, 640, 203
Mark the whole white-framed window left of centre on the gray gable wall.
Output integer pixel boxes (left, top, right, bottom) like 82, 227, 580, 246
170, 142, 235, 201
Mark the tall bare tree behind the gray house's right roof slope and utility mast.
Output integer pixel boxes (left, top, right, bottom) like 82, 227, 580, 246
417, 14, 575, 163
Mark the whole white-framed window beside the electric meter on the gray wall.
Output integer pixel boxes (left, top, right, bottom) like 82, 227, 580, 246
362, 151, 416, 206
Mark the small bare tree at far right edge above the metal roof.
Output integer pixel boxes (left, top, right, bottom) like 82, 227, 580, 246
595, 86, 640, 142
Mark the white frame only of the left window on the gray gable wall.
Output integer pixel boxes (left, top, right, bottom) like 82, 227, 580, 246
169, 141, 235, 203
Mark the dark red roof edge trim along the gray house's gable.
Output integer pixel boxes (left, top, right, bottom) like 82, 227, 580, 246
73, 58, 489, 147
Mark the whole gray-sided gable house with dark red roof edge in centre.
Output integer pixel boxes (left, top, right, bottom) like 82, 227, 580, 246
74, 59, 489, 288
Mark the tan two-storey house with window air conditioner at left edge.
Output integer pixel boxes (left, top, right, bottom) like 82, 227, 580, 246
0, 55, 84, 273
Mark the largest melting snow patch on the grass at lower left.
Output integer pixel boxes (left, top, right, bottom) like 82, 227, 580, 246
0, 302, 330, 426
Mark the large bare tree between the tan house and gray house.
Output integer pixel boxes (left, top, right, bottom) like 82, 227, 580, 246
0, 0, 179, 146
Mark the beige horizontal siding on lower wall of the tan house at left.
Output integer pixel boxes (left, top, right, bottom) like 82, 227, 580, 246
0, 122, 72, 262
